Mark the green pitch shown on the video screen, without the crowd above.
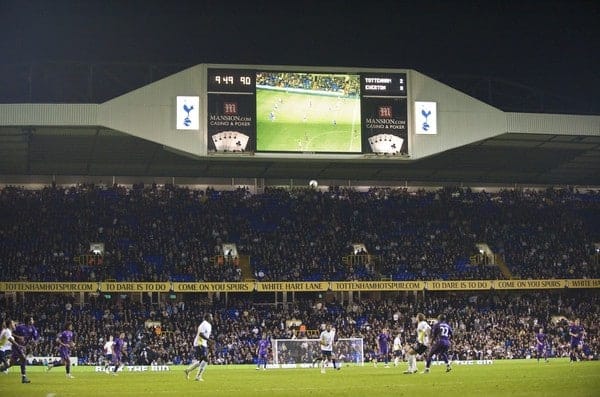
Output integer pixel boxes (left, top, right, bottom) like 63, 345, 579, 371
256, 89, 361, 153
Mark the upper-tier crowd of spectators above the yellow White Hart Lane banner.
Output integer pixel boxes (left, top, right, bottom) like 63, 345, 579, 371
0, 185, 600, 282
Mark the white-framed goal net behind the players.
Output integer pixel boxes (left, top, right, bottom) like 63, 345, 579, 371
271, 338, 364, 368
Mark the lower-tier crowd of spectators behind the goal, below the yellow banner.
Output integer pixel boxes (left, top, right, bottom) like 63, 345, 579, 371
1, 290, 600, 365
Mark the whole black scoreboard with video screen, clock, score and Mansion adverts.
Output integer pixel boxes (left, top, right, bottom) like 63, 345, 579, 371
206, 66, 409, 156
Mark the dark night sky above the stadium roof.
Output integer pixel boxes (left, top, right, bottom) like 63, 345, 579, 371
0, 0, 600, 106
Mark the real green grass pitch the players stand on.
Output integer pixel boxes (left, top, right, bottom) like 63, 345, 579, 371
0, 359, 600, 397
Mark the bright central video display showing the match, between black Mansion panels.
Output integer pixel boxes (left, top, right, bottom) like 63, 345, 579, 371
256, 72, 362, 153
